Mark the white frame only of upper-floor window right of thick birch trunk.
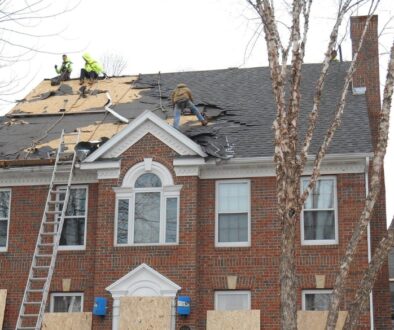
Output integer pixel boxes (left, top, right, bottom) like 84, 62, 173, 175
300, 175, 339, 245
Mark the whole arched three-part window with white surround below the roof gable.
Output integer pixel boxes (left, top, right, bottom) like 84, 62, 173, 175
114, 159, 181, 245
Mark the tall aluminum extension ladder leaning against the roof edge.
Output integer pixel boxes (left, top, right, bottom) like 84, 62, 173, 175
15, 130, 80, 330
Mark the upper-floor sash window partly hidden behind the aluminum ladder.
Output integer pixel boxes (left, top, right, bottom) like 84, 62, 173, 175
58, 186, 87, 250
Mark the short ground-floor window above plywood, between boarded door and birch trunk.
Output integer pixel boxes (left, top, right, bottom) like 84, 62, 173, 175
215, 291, 251, 311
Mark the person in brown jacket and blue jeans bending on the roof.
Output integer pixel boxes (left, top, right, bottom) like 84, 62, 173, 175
171, 84, 208, 129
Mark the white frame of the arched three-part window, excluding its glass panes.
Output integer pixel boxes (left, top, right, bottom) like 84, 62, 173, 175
113, 158, 182, 247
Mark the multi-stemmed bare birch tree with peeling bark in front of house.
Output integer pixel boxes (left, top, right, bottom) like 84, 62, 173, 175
247, 0, 394, 330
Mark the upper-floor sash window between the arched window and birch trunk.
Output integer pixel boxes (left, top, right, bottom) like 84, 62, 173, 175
215, 180, 250, 247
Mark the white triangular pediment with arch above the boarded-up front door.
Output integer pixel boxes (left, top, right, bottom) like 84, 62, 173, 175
106, 264, 181, 298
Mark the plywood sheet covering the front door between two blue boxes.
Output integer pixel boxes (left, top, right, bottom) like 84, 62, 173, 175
119, 297, 173, 330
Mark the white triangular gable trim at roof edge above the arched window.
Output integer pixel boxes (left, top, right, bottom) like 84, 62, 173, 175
84, 110, 207, 163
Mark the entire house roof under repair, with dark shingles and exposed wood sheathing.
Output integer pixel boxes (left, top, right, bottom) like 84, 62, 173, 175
0, 63, 372, 161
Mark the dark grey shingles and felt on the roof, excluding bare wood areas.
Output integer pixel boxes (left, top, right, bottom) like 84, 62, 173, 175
0, 63, 372, 159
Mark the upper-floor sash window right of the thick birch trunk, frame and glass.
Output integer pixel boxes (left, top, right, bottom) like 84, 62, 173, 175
301, 177, 338, 245
